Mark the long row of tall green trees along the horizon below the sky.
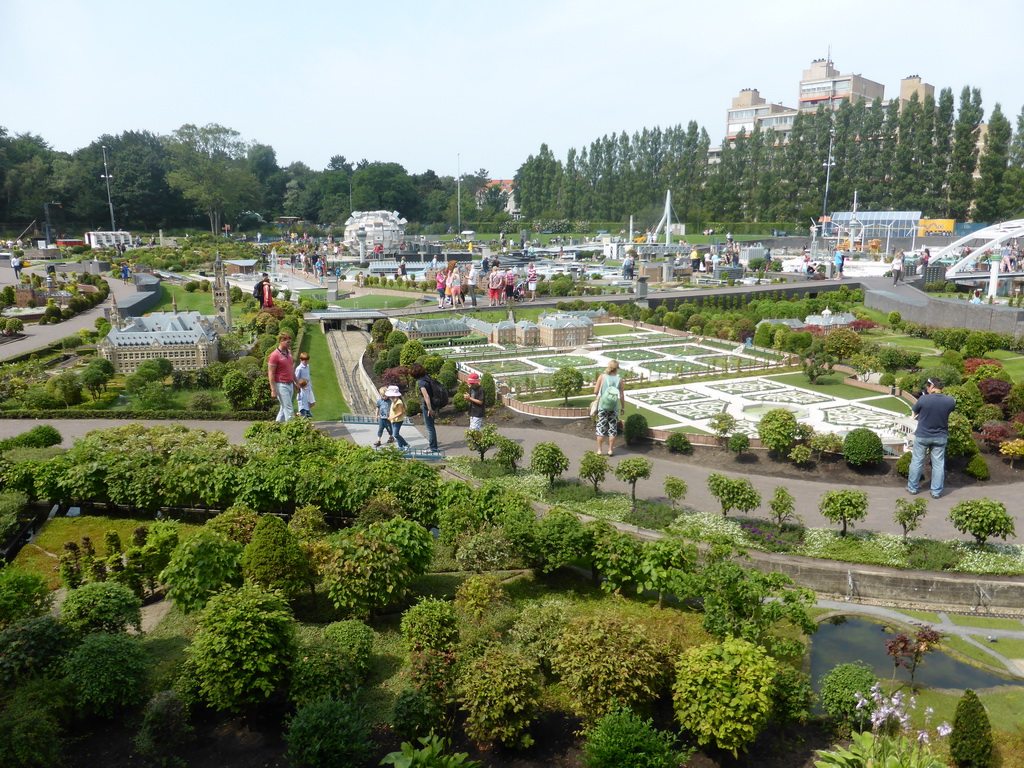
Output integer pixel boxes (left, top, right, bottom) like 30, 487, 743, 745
0, 86, 1024, 232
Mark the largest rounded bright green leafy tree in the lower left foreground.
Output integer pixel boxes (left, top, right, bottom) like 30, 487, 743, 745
185, 585, 296, 712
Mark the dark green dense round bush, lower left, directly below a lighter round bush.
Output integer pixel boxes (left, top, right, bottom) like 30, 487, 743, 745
66, 632, 150, 718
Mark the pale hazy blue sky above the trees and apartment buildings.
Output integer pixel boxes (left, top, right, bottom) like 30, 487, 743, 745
0, 0, 1024, 178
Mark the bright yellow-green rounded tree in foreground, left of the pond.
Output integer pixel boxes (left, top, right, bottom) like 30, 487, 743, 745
673, 638, 775, 755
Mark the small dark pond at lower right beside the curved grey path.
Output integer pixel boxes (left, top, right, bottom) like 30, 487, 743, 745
810, 617, 1024, 692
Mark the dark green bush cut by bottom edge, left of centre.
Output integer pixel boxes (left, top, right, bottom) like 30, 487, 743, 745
285, 698, 373, 768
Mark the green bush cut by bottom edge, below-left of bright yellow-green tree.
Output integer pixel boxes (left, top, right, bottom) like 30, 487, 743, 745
583, 707, 686, 768
